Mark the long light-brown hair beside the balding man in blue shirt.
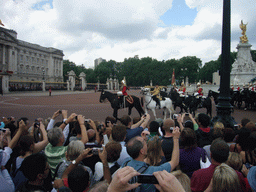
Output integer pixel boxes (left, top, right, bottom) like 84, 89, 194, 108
147, 136, 162, 166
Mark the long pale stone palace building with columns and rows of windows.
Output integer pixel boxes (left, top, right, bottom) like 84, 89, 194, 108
0, 27, 64, 92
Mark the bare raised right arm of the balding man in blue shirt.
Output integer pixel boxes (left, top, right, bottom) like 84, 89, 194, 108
169, 127, 180, 171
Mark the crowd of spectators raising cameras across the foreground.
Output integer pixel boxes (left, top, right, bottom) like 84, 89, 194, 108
0, 110, 256, 192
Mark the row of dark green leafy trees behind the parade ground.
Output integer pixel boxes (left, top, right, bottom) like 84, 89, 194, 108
63, 50, 256, 86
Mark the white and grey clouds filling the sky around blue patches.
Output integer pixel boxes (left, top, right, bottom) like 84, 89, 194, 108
0, 0, 256, 67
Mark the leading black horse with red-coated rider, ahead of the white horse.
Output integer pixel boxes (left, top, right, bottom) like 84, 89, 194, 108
100, 90, 145, 119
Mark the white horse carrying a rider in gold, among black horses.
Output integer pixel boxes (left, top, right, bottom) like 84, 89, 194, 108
142, 88, 175, 119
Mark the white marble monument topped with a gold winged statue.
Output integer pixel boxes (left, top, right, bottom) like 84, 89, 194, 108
230, 21, 256, 85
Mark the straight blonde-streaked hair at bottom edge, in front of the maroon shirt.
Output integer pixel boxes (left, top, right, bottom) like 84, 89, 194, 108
211, 163, 242, 192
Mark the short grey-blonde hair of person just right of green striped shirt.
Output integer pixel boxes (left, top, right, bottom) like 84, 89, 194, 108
67, 140, 85, 161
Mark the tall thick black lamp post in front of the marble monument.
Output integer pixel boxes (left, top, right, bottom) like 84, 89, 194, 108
212, 0, 235, 128
